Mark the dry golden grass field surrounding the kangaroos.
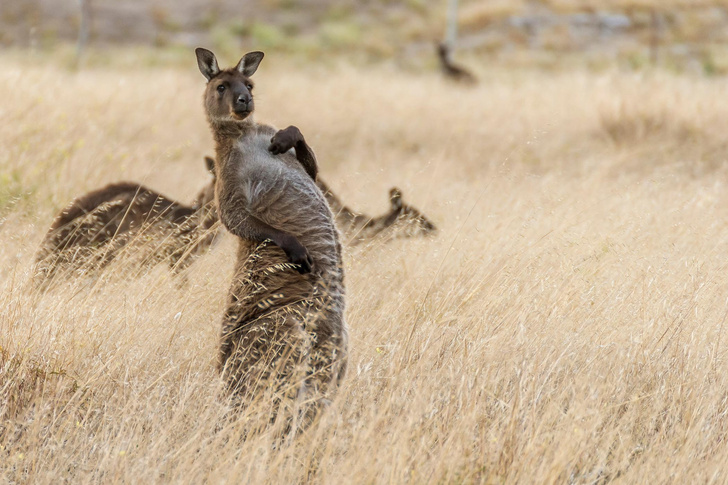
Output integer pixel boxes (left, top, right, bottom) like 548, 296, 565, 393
0, 52, 728, 483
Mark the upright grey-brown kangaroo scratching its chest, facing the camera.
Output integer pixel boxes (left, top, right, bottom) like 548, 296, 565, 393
195, 48, 347, 424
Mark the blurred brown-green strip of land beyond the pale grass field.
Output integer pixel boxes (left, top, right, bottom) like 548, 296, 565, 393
0, 0, 728, 75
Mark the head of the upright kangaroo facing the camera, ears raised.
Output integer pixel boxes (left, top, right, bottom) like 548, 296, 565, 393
195, 47, 263, 121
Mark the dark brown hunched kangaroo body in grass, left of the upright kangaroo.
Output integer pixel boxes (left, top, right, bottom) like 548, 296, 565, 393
36, 158, 217, 285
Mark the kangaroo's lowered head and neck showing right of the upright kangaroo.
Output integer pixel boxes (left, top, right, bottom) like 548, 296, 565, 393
316, 179, 437, 245
